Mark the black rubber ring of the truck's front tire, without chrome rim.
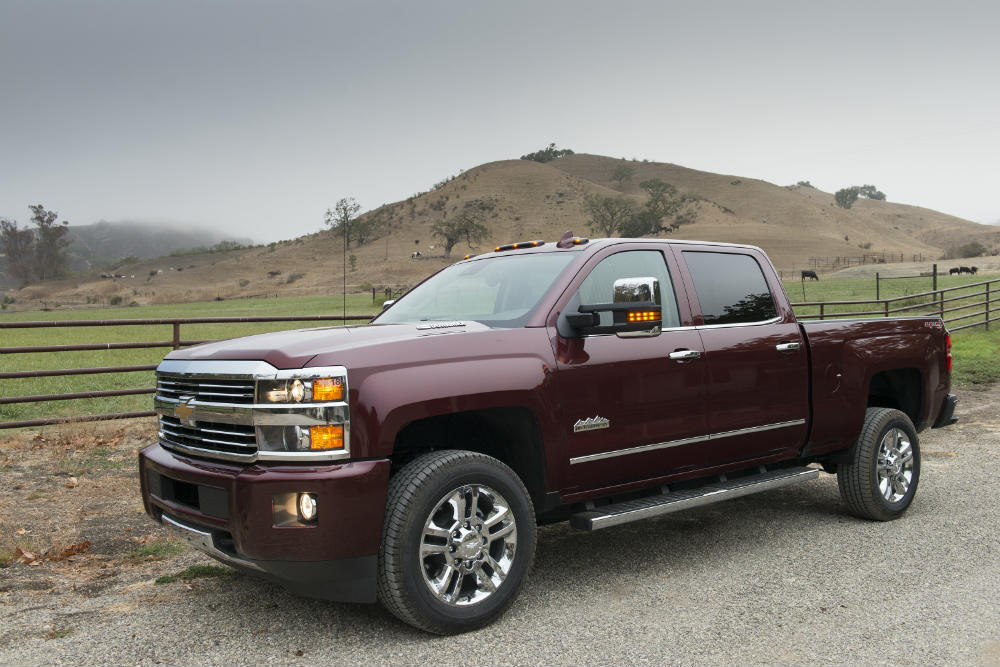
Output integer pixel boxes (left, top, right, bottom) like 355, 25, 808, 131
390, 457, 535, 633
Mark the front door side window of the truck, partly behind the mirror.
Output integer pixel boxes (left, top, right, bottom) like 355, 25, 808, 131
577, 250, 681, 328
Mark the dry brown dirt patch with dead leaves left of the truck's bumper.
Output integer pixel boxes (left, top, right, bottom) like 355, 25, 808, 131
0, 418, 188, 612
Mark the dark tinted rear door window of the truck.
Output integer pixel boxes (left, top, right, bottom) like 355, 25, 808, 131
683, 250, 778, 324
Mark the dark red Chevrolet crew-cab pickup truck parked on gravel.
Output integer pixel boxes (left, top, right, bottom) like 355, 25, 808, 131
140, 235, 955, 633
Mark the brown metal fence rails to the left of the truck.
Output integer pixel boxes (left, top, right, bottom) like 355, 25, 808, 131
0, 315, 375, 429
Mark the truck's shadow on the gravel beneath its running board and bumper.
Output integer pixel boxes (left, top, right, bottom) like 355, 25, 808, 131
221, 477, 857, 644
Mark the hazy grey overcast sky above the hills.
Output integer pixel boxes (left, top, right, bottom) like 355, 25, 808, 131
0, 0, 1000, 242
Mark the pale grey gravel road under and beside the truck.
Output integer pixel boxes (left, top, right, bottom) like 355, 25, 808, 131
0, 387, 1000, 665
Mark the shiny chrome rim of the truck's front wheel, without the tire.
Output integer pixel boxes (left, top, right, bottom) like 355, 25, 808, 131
420, 484, 517, 606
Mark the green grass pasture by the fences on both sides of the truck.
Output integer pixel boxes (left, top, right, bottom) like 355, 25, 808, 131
0, 276, 1000, 422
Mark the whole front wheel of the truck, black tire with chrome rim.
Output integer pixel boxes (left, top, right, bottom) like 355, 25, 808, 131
378, 450, 535, 635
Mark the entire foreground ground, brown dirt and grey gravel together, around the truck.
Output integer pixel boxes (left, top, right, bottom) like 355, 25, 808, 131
0, 386, 1000, 665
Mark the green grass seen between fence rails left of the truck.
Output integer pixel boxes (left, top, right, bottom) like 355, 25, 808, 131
0, 294, 380, 422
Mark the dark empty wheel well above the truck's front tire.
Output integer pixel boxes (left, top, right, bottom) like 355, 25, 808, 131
390, 407, 546, 506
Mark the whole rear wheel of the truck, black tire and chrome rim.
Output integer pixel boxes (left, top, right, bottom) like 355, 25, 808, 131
837, 408, 920, 521
